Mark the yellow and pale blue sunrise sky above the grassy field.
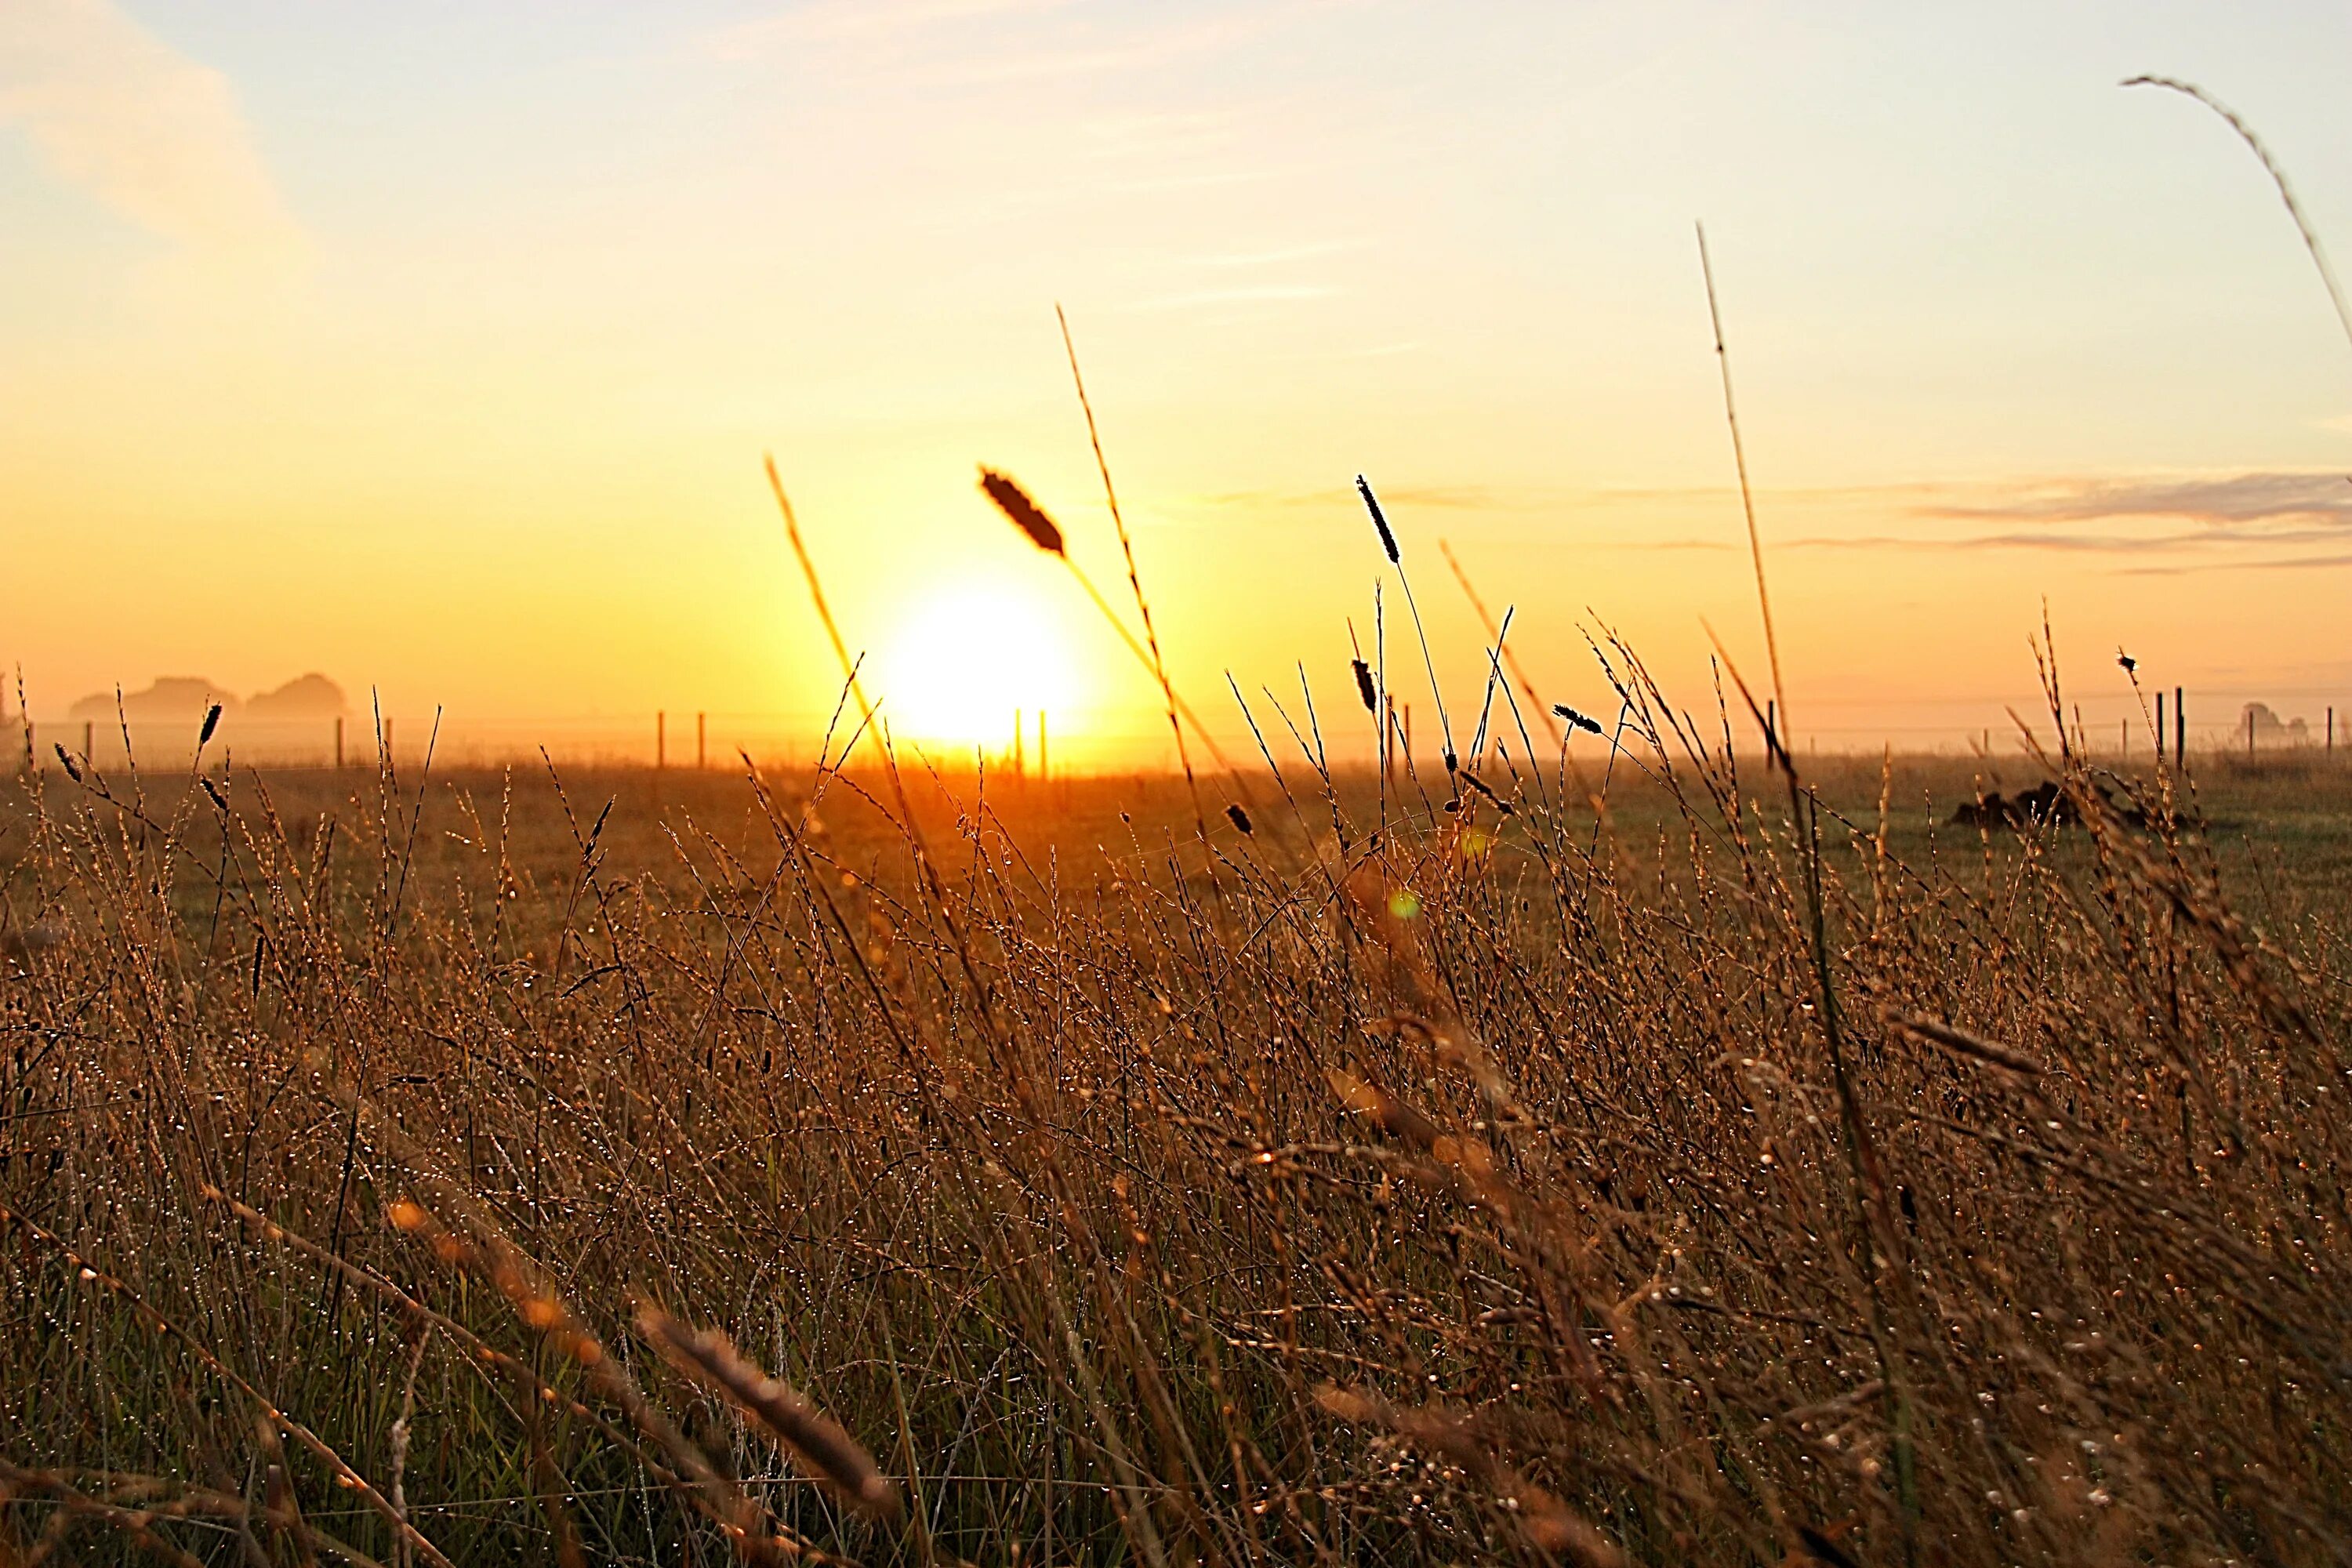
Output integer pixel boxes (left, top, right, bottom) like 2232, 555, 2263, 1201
0, 0, 2352, 764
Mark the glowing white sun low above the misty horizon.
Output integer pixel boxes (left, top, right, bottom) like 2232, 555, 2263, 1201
875, 576, 1084, 753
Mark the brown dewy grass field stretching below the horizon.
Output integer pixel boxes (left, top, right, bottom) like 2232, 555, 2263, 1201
0, 700, 2352, 1568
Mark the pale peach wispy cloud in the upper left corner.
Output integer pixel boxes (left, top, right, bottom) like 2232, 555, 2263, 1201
0, 0, 301, 256
